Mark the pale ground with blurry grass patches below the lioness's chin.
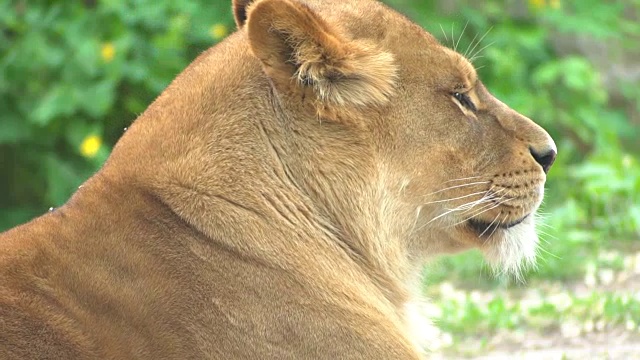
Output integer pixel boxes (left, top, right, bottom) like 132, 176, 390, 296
423, 249, 640, 360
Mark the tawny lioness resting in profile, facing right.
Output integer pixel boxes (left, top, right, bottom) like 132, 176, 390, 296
0, 0, 556, 359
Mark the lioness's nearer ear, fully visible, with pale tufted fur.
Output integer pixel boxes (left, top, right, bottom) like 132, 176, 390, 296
246, 0, 396, 107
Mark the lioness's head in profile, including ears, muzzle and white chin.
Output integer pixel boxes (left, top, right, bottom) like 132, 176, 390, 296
208, 0, 557, 282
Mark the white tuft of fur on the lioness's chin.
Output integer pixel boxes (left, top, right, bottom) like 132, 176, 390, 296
482, 217, 538, 281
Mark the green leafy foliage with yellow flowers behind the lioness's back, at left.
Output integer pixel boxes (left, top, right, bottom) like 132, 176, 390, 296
0, 0, 234, 229
